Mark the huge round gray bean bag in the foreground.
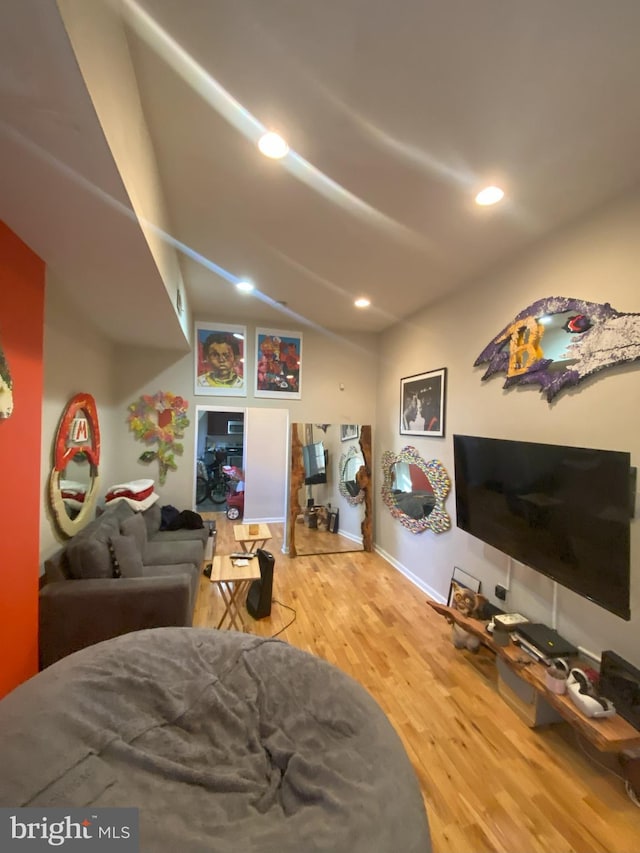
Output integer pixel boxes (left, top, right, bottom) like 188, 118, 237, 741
0, 628, 431, 853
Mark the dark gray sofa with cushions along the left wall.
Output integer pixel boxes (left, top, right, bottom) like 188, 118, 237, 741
39, 501, 215, 668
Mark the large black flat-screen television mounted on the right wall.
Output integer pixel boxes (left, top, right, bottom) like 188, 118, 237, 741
453, 435, 635, 620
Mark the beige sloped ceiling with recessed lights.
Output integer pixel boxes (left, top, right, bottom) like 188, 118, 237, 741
0, 0, 640, 346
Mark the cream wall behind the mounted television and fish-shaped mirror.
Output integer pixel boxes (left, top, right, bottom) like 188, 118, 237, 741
374, 194, 640, 665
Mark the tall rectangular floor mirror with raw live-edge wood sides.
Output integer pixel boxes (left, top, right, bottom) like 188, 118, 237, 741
287, 423, 373, 557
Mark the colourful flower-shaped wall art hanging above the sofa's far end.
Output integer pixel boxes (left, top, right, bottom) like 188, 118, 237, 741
127, 391, 189, 485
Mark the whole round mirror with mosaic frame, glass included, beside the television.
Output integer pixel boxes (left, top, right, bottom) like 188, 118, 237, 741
382, 447, 451, 533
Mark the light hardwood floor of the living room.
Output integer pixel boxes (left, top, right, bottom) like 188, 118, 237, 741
194, 515, 640, 853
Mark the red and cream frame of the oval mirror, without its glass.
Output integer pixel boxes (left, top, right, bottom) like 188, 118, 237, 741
49, 394, 100, 536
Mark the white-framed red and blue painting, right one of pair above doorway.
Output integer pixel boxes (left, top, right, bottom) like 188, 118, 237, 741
255, 329, 302, 400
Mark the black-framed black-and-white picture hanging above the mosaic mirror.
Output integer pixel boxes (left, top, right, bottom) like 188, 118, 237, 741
400, 367, 447, 438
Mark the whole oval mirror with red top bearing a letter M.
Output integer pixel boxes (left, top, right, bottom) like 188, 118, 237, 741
49, 394, 100, 536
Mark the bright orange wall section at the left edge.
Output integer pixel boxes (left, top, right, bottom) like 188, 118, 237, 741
0, 222, 45, 697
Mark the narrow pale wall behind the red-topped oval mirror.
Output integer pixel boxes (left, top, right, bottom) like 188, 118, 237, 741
40, 273, 120, 564
